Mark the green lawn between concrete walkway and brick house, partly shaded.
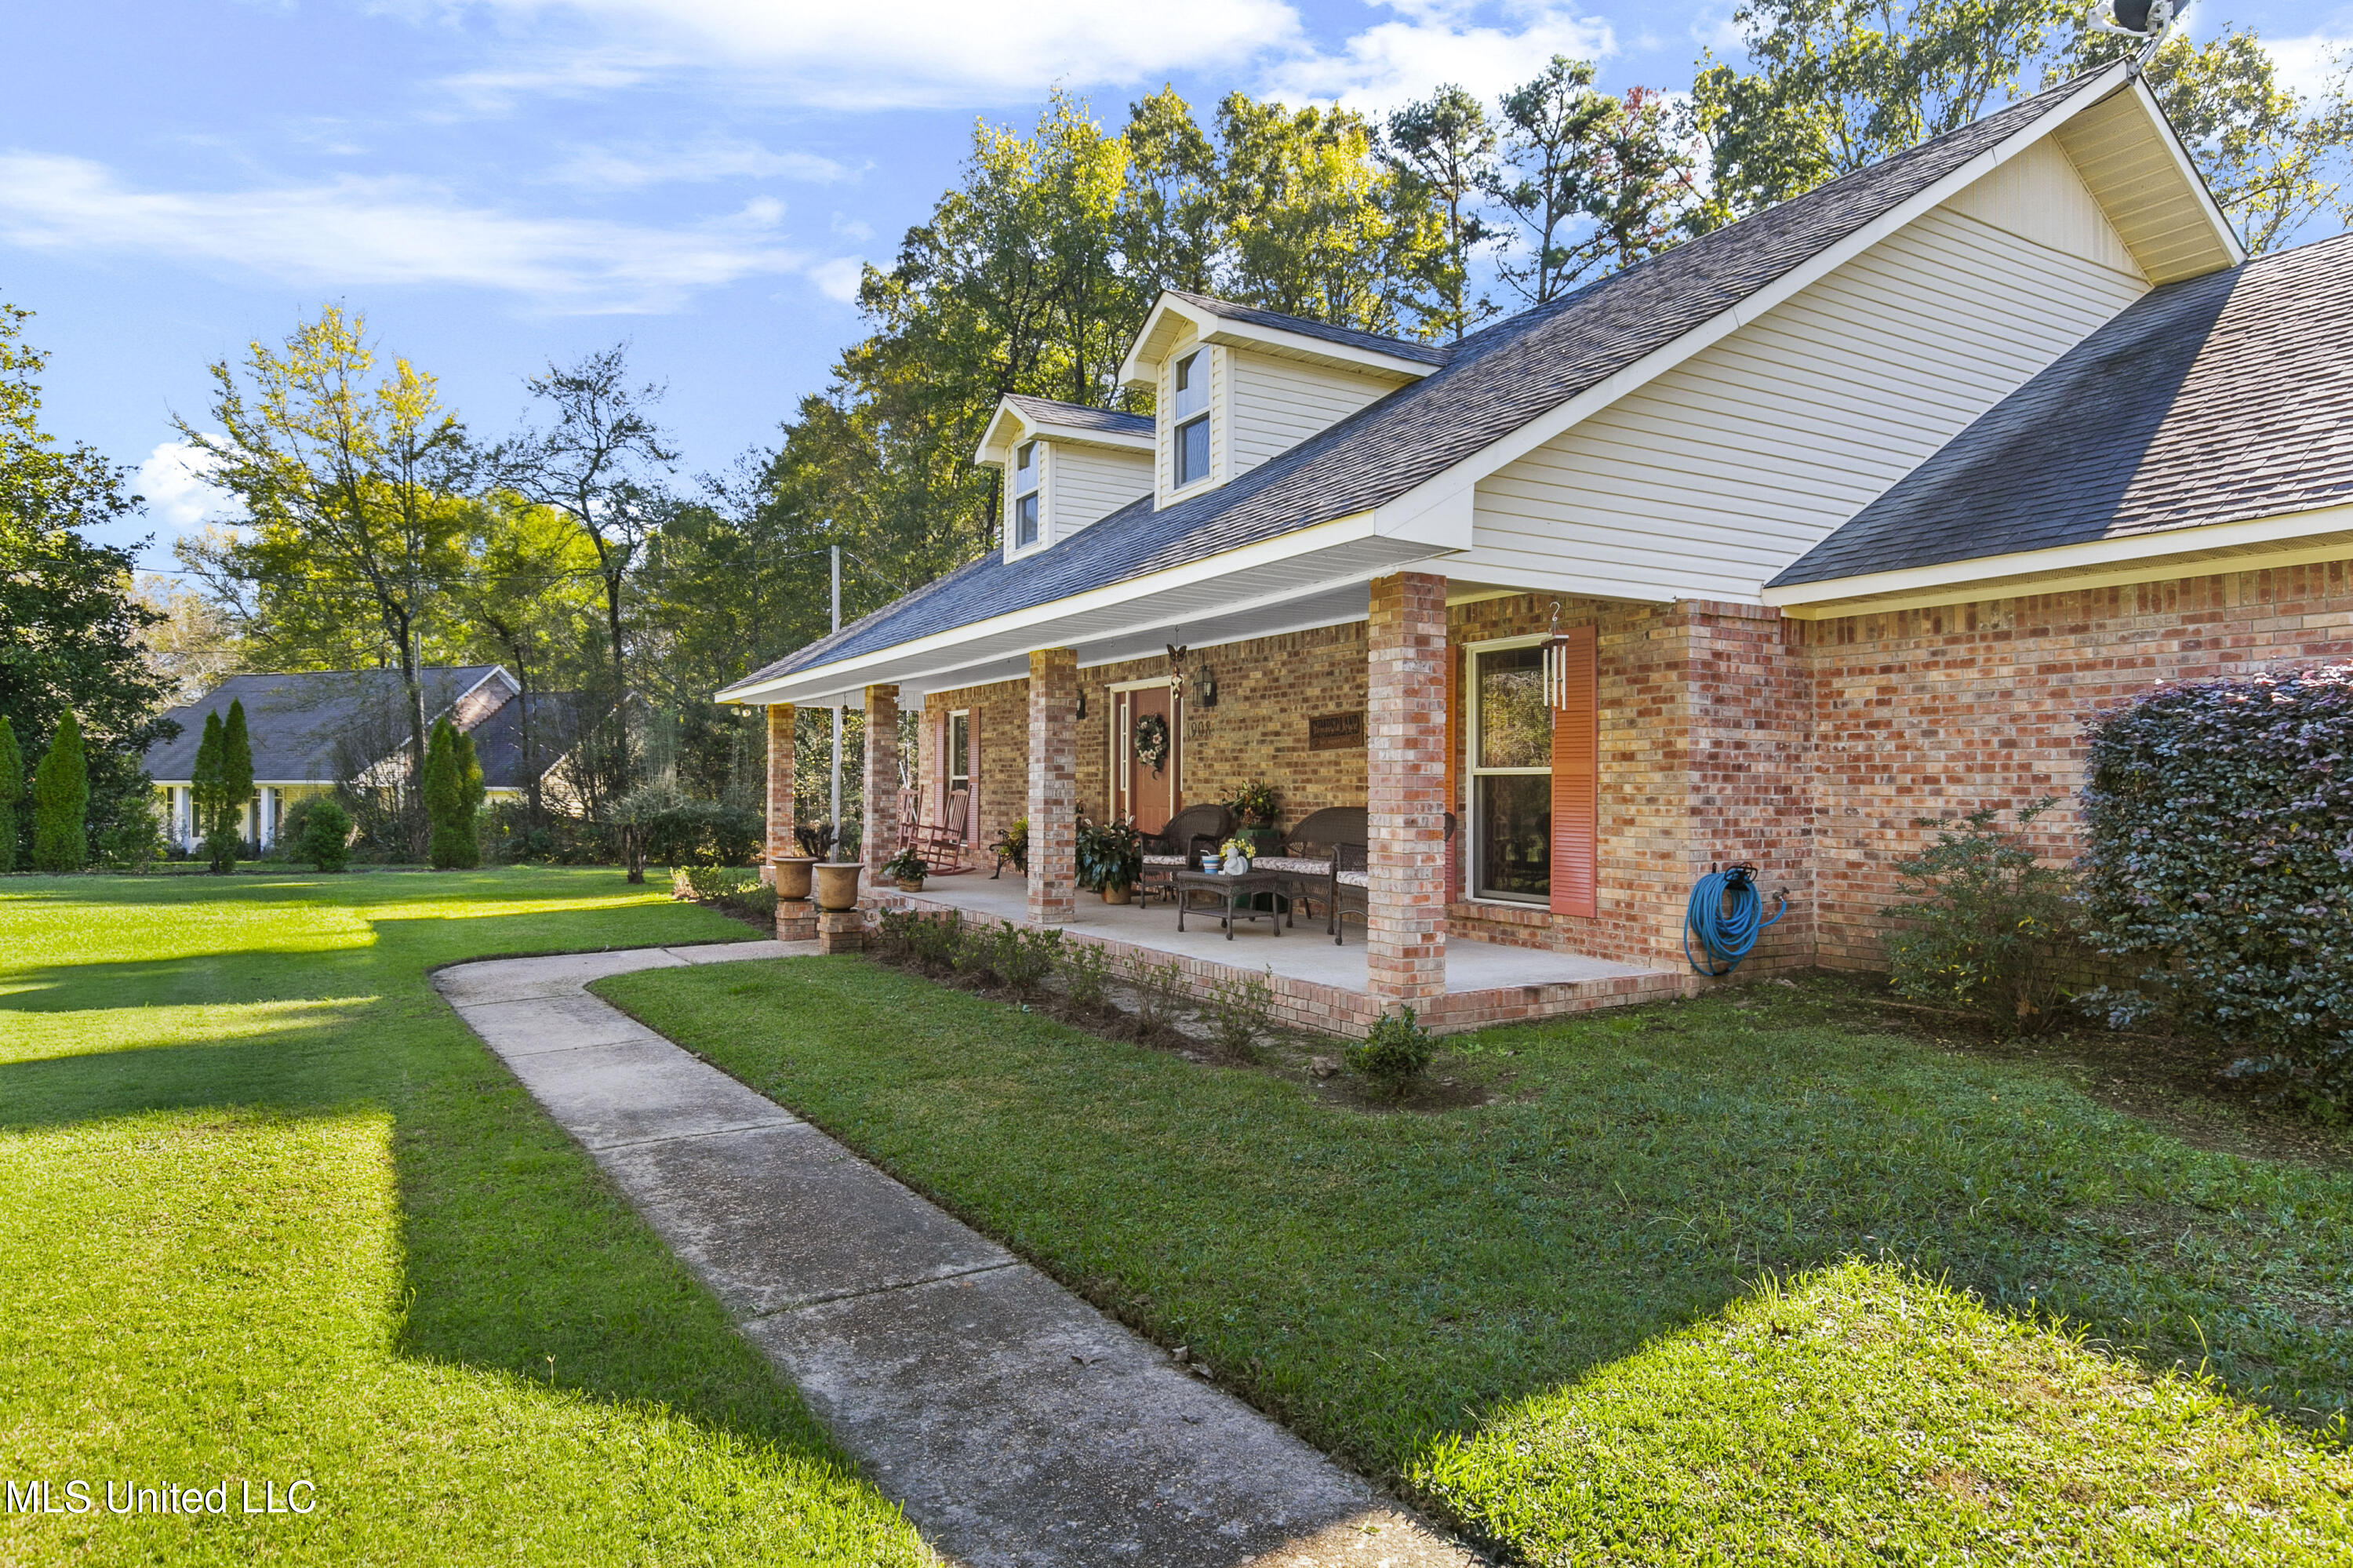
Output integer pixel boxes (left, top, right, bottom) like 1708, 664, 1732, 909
598, 959, 2353, 1563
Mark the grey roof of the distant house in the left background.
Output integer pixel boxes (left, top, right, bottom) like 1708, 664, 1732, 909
146, 664, 501, 784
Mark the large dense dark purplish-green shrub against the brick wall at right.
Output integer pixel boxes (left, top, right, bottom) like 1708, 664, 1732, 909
2082, 666, 2353, 1104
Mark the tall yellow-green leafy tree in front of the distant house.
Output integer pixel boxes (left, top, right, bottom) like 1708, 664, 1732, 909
174, 306, 475, 842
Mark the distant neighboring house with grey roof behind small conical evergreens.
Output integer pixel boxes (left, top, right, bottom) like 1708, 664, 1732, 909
146, 664, 579, 850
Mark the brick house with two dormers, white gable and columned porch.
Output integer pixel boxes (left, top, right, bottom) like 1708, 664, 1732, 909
720, 64, 2353, 1027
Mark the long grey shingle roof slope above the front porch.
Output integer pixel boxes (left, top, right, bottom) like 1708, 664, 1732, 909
739, 73, 2115, 685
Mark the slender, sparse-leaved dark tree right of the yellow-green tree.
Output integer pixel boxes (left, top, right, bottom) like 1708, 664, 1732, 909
494, 344, 678, 789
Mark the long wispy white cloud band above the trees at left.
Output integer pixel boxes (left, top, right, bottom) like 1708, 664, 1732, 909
0, 153, 838, 313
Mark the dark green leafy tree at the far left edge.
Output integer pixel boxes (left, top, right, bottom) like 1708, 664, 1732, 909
0, 304, 176, 843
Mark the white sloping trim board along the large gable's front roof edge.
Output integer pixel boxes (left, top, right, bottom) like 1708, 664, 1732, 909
1377, 61, 2202, 544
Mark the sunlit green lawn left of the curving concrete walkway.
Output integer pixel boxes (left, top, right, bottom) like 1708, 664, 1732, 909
0, 871, 929, 1566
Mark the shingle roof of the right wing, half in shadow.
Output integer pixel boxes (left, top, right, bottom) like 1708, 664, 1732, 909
1772, 235, 2353, 586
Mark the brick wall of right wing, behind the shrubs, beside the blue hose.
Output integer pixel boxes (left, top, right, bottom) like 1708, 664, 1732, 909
1798, 560, 2353, 968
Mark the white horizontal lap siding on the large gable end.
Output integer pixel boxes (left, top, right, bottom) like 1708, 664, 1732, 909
1447, 207, 2148, 600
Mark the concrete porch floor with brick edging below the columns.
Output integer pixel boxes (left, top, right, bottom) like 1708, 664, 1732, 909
873, 871, 1701, 1034
